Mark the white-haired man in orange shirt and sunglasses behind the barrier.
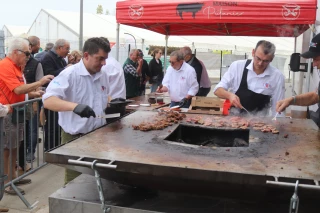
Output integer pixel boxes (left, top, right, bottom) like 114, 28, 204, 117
0, 38, 54, 194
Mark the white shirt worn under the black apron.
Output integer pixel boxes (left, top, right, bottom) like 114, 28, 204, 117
213, 60, 285, 115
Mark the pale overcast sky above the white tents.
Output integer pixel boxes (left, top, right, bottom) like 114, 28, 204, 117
0, 0, 117, 29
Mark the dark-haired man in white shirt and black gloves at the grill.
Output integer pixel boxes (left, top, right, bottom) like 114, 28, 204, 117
42, 38, 110, 183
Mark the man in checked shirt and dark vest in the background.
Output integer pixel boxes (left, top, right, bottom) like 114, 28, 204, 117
123, 49, 143, 99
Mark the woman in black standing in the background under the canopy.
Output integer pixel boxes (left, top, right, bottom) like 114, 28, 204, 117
149, 49, 163, 92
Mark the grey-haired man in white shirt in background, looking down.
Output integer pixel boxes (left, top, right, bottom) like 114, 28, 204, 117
157, 50, 199, 108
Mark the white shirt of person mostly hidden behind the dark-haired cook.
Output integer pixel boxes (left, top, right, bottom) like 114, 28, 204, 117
101, 55, 126, 99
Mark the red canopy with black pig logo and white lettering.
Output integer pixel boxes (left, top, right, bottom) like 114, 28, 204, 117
116, 0, 317, 37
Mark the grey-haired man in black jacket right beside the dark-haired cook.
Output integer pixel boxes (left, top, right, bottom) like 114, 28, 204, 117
41, 39, 72, 150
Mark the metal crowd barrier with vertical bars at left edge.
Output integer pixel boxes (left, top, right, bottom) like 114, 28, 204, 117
0, 98, 60, 209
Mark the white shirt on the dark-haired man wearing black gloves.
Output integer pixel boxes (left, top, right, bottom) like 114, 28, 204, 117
42, 60, 108, 135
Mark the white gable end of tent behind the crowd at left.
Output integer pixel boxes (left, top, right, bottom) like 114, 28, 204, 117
28, 11, 79, 50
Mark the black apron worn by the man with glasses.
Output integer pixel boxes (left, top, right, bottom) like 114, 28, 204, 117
236, 60, 271, 114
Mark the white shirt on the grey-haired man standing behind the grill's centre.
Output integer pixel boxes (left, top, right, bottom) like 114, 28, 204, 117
162, 62, 199, 102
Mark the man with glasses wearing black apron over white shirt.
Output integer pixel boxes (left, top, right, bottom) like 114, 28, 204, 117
214, 40, 285, 115
